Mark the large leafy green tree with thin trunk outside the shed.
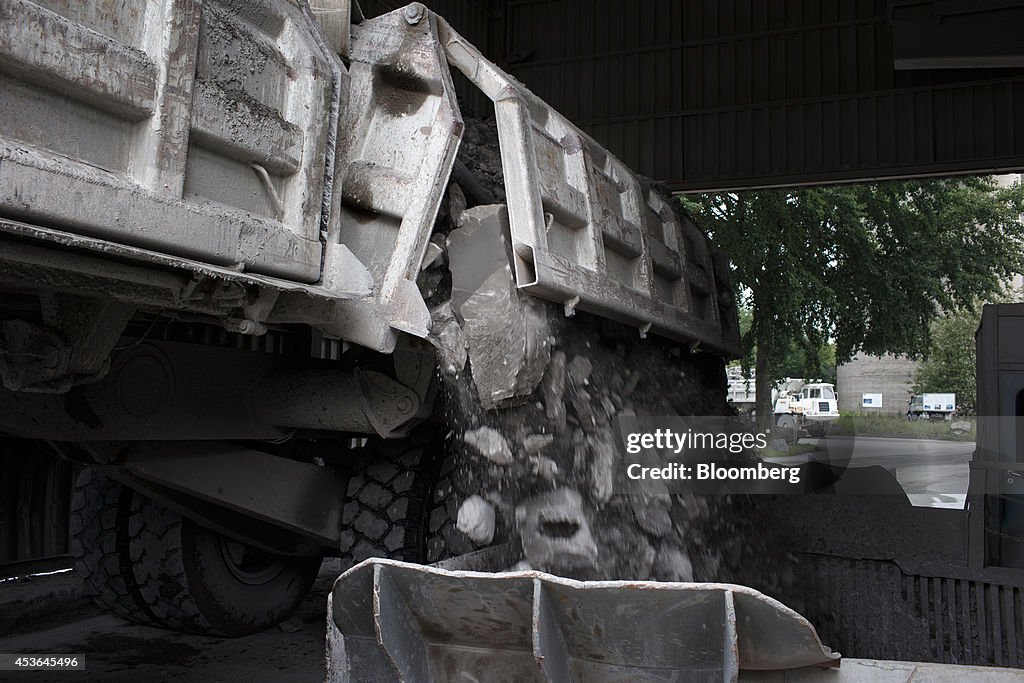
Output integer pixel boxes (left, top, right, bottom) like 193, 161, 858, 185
683, 177, 1024, 424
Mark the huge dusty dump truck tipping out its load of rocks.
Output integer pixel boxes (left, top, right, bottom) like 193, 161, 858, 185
0, 0, 739, 636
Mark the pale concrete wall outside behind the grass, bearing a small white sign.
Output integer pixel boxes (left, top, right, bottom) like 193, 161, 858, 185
836, 354, 918, 415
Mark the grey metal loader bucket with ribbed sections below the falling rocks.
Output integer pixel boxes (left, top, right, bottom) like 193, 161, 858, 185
327, 559, 840, 683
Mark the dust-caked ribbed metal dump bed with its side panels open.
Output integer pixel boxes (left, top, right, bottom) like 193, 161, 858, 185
0, 0, 737, 362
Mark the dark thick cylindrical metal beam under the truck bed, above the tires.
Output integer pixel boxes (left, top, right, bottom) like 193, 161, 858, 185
0, 341, 430, 441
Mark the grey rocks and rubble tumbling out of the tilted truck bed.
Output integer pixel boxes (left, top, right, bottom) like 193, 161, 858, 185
420, 120, 786, 593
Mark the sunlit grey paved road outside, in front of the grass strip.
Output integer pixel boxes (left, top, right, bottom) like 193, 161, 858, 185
772, 436, 974, 509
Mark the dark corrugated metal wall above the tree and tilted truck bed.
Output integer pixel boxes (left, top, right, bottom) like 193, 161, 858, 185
368, 0, 1024, 189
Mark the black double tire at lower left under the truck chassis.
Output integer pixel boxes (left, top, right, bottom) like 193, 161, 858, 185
73, 468, 321, 637
